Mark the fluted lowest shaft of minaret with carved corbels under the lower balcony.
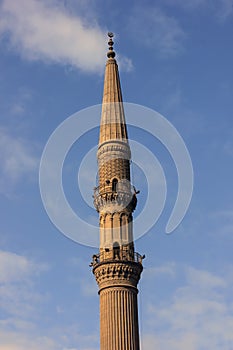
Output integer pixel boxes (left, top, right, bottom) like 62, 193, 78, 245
93, 262, 142, 350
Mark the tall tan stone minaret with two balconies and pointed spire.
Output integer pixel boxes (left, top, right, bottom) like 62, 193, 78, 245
91, 33, 143, 350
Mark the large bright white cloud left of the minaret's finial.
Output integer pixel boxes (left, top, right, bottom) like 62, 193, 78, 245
0, 0, 106, 71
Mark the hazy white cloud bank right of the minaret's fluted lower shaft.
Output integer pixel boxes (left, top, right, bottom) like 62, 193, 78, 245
142, 266, 233, 350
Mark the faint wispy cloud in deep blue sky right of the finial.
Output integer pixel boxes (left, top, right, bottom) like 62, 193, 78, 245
128, 6, 185, 57
